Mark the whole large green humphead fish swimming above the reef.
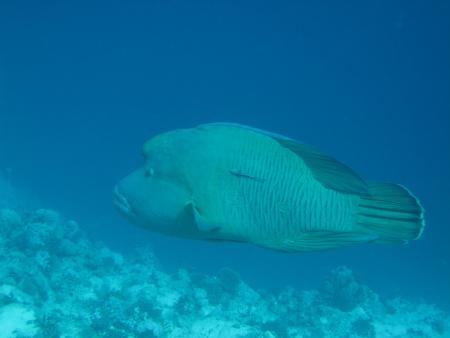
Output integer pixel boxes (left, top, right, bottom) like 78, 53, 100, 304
114, 123, 424, 252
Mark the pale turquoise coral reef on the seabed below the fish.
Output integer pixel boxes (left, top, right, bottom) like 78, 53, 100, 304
0, 209, 450, 338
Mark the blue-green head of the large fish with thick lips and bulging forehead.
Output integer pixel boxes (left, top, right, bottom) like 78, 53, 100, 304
114, 131, 190, 235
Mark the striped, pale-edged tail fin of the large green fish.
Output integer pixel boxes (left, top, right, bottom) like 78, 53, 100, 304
356, 183, 425, 243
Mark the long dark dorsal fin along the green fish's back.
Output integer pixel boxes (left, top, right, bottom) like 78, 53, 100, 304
200, 123, 369, 196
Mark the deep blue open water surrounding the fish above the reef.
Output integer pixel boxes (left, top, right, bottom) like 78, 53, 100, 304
0, 0, 450, 307
